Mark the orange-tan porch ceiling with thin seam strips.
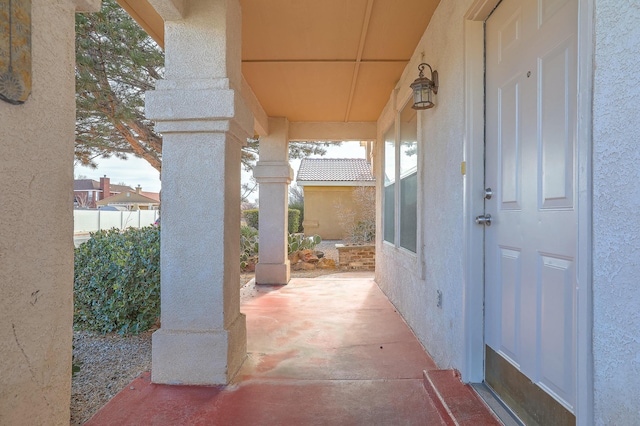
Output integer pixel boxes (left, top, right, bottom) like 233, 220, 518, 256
118, 0, 440, 122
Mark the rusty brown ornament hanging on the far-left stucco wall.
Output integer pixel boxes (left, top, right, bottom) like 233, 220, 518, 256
0, 0, 31, 105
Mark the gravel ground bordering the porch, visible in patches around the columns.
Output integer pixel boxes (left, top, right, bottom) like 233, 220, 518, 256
71, 241, 340, 426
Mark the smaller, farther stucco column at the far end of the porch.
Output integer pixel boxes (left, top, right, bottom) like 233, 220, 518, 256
253, 118, 293, 285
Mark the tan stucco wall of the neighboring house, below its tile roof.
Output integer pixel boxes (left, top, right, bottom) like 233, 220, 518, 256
303, 186, 373, 240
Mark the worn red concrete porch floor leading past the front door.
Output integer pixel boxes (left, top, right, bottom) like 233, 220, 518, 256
87, 273, 500, 425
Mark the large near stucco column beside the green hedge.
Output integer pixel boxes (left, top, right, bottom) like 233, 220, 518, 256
146, 0, 253, 385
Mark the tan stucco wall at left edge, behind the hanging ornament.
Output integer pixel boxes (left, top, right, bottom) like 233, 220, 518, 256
0, 0, 75, 425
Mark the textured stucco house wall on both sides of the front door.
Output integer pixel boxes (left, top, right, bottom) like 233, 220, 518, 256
376, 0, 640, 425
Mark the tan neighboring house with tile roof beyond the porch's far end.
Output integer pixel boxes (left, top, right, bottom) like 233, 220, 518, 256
296, 158, 376, 240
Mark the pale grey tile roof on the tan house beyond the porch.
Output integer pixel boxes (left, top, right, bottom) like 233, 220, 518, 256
296, 158, 376, 182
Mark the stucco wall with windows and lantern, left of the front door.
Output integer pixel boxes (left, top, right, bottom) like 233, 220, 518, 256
376, 0, 471, 369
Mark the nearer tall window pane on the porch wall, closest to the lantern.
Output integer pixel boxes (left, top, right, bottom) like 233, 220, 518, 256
398, 104, 418, 253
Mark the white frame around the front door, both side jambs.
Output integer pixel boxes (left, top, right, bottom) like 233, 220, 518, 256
461, 0, 595, 426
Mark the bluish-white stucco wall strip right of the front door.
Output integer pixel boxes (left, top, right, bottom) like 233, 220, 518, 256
593, 0, 640, 425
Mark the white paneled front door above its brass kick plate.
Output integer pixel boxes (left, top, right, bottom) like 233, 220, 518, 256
485, 0, 578, 413
